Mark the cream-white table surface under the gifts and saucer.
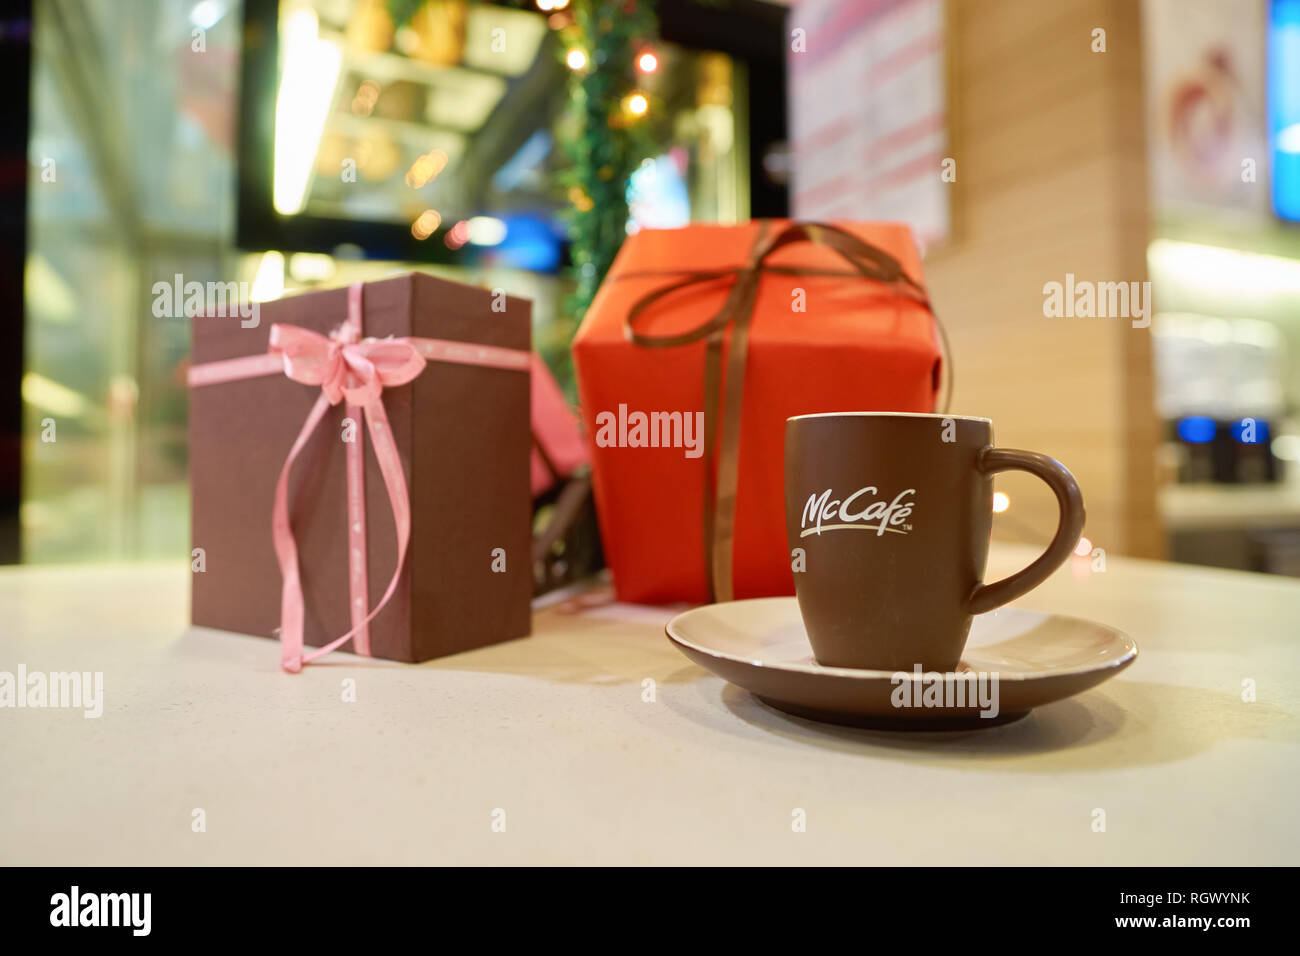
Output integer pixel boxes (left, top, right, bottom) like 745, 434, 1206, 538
0, 548, 1300, 865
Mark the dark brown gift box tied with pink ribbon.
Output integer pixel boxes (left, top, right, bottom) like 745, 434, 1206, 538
190, 274, 532, 661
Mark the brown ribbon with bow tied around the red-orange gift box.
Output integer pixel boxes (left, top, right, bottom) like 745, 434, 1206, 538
618, 221, 953, 601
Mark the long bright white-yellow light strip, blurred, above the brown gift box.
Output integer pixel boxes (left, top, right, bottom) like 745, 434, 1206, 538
272, 7, 343, 216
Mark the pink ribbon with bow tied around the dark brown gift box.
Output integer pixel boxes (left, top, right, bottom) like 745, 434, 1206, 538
190, 282, 530, 674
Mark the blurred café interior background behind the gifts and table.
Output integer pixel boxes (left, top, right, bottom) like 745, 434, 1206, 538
0, 0, 1300, 576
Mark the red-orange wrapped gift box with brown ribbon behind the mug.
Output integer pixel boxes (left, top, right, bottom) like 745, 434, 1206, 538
573, 220, 943, 604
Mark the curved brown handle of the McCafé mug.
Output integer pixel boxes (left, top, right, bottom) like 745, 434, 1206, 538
967, 446, 1084, 614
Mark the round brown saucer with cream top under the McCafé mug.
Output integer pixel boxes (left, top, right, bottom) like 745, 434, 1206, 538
667, 597, 1138, 730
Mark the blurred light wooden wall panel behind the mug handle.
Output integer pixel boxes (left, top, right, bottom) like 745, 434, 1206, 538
926, 0, 1164, 557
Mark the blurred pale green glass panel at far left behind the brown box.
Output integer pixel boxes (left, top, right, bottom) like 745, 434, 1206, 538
22, 0, 241, 562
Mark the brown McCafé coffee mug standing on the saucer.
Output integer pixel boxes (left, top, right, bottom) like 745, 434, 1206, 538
785, 412, 1084, 671
